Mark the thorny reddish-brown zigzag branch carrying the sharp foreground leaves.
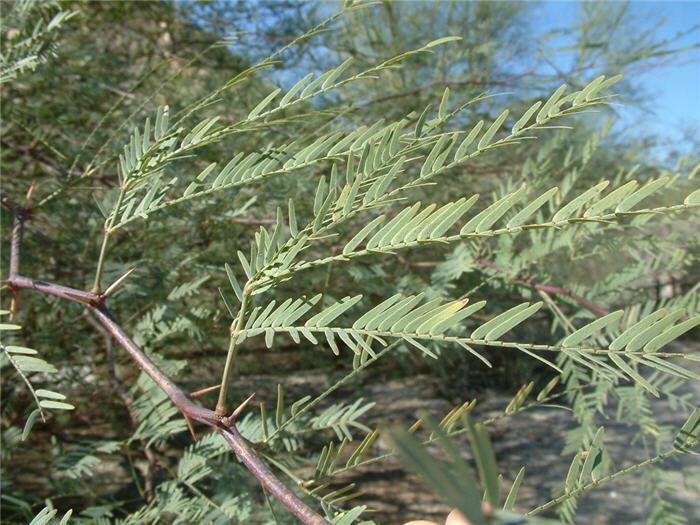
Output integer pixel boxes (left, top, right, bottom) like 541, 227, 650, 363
2, 209, 330, 525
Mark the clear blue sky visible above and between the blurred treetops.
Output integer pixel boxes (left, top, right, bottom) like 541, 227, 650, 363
194, 0, 700, 159
